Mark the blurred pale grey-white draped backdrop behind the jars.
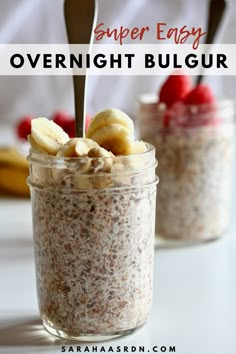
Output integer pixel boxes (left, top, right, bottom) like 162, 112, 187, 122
0, 0, 236, 124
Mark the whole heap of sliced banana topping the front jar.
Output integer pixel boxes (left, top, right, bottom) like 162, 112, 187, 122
28, 109, 147, 189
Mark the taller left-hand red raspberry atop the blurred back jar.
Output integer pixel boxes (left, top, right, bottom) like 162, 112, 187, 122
159, 71, 192, 107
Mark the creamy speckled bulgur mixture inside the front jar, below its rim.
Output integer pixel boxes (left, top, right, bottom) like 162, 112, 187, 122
32, 184, 155, 334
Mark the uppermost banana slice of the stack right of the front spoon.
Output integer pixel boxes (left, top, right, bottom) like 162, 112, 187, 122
86, 108, 134, 138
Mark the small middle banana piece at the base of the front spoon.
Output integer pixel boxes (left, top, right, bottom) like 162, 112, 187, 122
57, 138, 99, 157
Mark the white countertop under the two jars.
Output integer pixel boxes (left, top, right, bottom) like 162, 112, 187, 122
0, 129, 236, 354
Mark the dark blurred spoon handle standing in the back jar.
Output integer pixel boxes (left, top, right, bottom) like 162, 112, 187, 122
197, 0, 227, 85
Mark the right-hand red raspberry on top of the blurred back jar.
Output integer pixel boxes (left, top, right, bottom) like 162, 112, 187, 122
184, 84, 215, 105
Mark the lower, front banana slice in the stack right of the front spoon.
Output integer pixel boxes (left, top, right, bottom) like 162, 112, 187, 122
87, 124, 133, 155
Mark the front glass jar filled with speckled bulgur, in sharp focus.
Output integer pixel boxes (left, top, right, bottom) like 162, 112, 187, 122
28, 145, 157, 341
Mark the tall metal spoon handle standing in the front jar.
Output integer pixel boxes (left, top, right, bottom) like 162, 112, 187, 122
64, 0, 97, 137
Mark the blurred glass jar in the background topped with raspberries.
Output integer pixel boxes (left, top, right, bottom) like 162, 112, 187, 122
137, 97, 234, 246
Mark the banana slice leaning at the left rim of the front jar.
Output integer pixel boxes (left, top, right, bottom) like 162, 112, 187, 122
31, 117, 69, 155
